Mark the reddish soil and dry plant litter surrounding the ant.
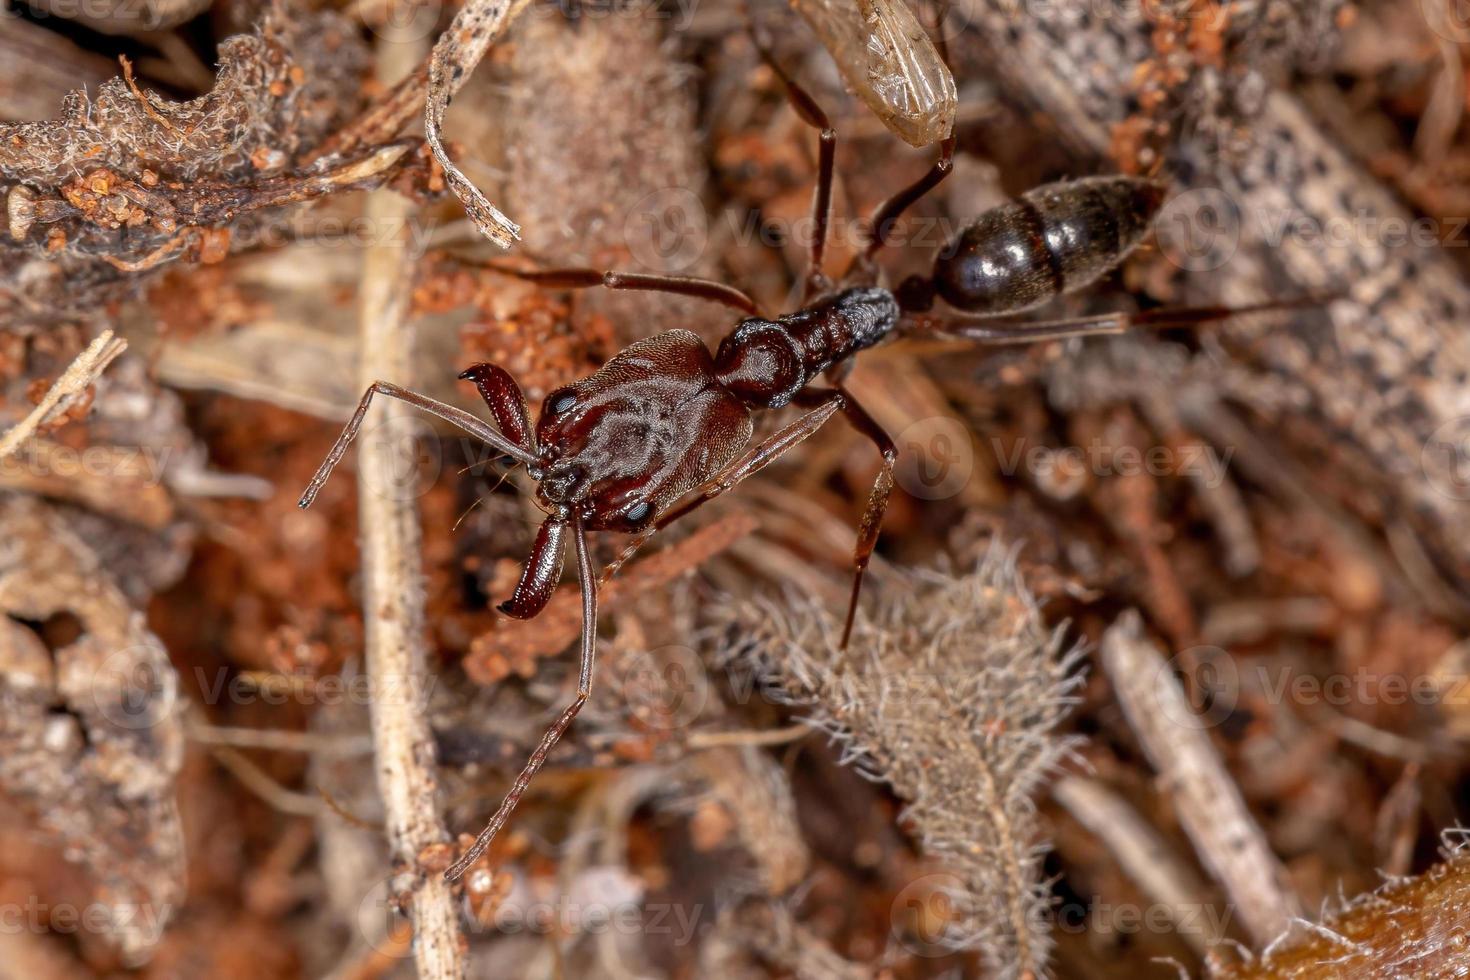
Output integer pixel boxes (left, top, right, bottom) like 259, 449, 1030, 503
0, 0, 1470, 980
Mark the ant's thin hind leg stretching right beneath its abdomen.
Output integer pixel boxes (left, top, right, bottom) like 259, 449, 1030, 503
903, 294, 1336, 344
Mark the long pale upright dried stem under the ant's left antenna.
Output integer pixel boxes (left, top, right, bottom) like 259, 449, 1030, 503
348, 32, 465, 980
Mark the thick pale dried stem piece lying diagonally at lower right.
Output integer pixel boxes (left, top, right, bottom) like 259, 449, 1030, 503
1103, 611, 1301, 943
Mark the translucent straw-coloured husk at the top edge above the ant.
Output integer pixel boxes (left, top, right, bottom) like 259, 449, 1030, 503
792, 0, 957, 147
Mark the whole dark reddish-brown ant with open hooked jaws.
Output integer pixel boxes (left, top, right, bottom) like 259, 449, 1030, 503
300, 41, 1286, 882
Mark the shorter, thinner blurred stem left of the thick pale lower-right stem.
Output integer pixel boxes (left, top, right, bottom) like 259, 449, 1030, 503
1051, 776, 1220, 956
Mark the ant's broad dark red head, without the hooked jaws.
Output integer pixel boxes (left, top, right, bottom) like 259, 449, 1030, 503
537, 331, 751, 532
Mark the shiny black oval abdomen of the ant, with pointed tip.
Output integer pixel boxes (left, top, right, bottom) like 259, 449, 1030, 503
933, 176, 1163, 313
